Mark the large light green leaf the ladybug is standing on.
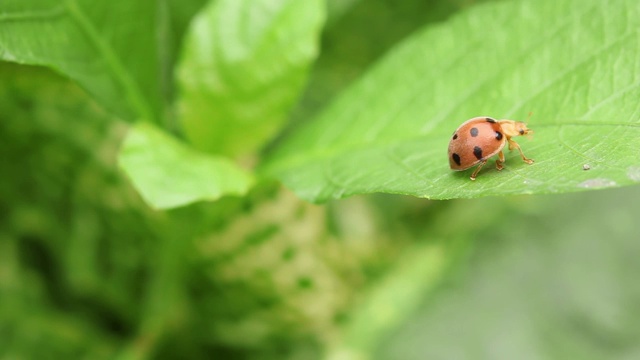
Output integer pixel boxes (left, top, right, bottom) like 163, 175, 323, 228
262, 0, 640, 202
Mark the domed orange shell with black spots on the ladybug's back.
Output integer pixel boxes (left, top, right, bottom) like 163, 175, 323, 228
449, 116, 507, 171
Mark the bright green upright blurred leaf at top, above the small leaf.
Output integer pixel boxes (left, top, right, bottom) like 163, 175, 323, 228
178, 0, 324, 157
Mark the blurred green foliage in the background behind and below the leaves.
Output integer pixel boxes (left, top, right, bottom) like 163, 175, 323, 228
0, 0, 640, 360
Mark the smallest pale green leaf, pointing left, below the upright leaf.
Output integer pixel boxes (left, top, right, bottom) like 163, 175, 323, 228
119, 122, 253, 209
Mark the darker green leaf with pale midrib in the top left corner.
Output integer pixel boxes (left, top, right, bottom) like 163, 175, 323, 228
0, 0, 163, 120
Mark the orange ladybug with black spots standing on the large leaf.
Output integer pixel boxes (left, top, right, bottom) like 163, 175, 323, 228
449, 116, 533, 180
